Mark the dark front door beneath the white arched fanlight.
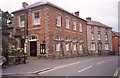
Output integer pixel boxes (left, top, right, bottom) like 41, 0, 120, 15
30, 41, 37, 57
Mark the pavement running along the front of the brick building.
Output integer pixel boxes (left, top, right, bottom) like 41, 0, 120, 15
2, 56, 120, 75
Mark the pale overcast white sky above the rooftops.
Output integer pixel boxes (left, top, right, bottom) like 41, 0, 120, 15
0, 0, 119, 31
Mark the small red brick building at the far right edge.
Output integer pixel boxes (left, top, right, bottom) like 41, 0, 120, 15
112, 31, 120, 54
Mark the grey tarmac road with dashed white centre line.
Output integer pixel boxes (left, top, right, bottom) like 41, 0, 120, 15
38, 56, 118, 76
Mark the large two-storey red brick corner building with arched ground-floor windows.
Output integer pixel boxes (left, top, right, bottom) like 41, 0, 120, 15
13, 2, 87, 57
